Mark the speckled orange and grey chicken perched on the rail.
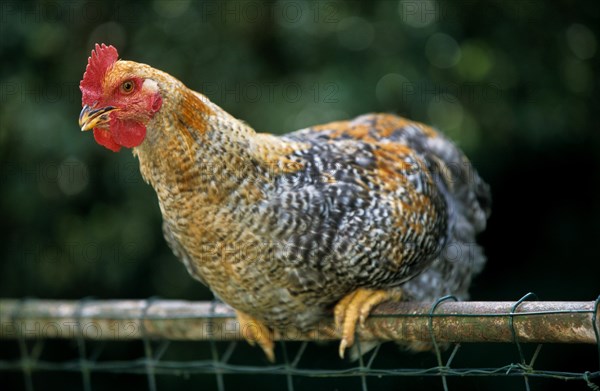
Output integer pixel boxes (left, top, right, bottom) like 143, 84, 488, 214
79, 44, 490, 360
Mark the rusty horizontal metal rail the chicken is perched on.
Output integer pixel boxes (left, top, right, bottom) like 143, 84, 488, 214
0, 300, 600, 344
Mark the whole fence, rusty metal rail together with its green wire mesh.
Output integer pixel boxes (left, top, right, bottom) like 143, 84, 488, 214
0, 294, 600, 391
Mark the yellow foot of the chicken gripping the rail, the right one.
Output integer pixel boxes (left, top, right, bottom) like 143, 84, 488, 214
333, 288, 401, 358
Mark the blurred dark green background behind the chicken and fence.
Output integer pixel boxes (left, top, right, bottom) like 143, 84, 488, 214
0, 0, 600, 389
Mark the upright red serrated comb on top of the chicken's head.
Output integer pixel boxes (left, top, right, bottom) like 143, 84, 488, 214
79, 44, 119, 105
